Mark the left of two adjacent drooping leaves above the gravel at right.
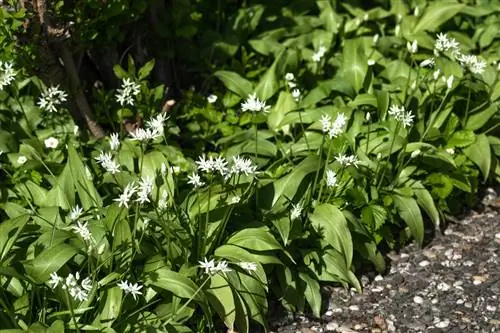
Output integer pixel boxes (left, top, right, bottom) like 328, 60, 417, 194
392, 194, 424, 246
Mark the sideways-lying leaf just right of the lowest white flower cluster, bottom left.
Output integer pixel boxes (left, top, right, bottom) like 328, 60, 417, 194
146, 268, 206, 304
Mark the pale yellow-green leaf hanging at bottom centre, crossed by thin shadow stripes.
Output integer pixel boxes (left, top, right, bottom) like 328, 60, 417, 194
206, 274, 239, 330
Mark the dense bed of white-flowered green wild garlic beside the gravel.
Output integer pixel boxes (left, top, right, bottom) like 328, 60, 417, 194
0, 0, 500, 332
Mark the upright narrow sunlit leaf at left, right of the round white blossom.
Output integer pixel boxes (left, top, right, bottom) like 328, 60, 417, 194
68, 145, 102, 210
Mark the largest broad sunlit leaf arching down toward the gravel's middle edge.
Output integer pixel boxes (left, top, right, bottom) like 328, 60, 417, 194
309, 204, 353, 268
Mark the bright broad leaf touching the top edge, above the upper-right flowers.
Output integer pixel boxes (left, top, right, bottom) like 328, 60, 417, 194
413, 1, 465, 32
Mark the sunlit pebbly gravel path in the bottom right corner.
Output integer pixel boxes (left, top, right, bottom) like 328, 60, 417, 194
271, 191, 500, 333
